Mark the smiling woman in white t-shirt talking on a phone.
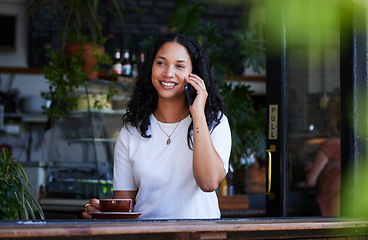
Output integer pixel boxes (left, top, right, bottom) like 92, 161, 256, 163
83, 34, 231, 219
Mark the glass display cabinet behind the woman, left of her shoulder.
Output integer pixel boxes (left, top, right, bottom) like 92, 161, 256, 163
44, 80, 133, 199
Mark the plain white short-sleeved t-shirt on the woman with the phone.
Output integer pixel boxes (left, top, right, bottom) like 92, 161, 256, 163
113, 114, 231, 219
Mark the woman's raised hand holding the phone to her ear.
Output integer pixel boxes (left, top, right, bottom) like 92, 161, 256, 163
185, 73, 208, 115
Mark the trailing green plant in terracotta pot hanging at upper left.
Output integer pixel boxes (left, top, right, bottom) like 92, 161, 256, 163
29, 0, 125, 118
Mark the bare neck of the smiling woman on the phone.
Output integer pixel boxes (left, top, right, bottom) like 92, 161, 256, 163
153, 101, 189, 123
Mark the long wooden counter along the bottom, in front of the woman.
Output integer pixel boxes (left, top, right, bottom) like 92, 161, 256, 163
0, 218, 368, 240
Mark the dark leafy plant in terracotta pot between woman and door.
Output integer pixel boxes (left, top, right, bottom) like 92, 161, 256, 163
222, 84, 266, 194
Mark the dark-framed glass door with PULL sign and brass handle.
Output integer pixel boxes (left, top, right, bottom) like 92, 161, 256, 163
266, 0, 340, 217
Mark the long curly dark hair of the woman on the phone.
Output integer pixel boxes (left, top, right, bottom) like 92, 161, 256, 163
123, 33, 226, 149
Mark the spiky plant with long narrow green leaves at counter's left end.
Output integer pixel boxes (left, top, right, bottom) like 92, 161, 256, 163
0, 148, 45, 220
